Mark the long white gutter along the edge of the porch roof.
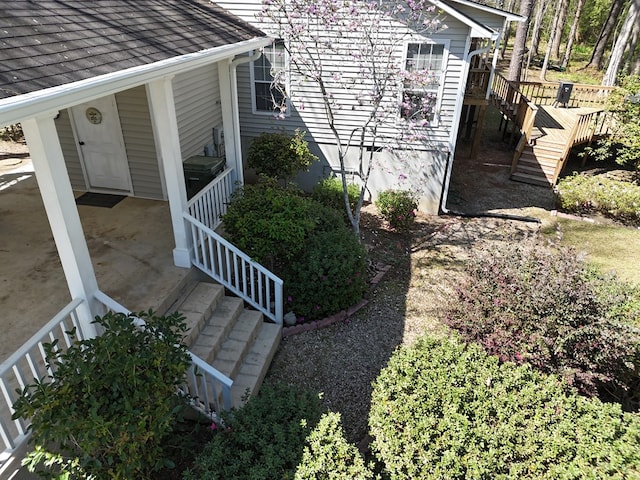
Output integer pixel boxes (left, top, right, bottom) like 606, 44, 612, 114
0, 37, 273, 126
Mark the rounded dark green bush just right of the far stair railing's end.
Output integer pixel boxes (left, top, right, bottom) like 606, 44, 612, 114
283, 226, 367, 321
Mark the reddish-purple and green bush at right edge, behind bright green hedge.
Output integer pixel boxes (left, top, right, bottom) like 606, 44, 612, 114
445, 244, 640, 409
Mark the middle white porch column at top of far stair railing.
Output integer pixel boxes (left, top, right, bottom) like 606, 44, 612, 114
147, 76, 191, 268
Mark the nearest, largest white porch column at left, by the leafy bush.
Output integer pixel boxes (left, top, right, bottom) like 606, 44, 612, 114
21, 112, 101, 337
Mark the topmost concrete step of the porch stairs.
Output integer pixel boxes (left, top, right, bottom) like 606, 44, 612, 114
173, 282, 224, 346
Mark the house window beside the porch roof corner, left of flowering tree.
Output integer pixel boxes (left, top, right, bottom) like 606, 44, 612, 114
251, 40, 286, 114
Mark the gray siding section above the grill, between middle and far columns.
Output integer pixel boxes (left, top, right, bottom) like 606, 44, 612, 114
173, 65, 222, 160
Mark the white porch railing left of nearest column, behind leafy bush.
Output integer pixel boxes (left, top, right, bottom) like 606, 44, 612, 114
0, 299, 84, 466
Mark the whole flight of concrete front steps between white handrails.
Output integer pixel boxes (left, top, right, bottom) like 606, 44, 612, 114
168, 281, 282, 407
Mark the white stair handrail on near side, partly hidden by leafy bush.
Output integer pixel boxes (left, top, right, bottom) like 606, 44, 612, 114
94, 290, 233, 418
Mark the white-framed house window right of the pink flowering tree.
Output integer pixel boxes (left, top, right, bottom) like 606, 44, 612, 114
400, 43, 447, 124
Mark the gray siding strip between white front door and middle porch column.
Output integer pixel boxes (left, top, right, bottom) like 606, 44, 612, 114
116, 86, 164, 200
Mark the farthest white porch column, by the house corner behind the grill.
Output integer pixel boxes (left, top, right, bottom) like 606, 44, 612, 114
218, 58, 244, 184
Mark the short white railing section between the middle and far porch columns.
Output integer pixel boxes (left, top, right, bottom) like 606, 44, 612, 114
187, 168, 234, 230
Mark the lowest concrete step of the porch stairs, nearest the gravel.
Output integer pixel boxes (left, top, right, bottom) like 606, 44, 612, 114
231, 323, 282, 408
